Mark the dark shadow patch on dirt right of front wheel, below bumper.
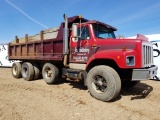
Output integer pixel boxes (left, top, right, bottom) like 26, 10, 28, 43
120, 83, 153, 100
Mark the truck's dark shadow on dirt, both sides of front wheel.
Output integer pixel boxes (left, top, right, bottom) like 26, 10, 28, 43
36, 79, 153, 102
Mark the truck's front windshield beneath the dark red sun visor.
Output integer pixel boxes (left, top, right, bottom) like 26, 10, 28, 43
93, 24, 116, 39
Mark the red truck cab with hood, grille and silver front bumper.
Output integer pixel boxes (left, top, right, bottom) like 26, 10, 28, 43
69, 20, 157, 81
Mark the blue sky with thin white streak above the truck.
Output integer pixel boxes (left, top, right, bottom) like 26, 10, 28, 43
0, 0, 160, 44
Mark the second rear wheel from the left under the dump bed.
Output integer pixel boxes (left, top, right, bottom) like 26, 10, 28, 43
21, 62, 34, 81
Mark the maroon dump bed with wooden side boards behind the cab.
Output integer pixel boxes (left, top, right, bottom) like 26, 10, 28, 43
8, 16, 88, 61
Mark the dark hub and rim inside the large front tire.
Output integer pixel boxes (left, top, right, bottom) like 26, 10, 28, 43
92, 75, 107, 93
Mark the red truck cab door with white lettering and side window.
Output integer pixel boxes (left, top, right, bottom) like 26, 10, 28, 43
70, 25, 92, 63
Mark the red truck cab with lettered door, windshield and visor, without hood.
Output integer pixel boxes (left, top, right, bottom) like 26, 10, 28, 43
70, 21, 116, 63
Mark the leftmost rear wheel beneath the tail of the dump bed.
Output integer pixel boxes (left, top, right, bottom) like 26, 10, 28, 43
11, 62, 22, 78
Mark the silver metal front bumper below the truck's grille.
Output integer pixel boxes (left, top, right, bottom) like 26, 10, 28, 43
132, 66, 158, 81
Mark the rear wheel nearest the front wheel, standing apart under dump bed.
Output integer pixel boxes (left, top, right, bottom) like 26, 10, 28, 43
42, 63, 59, 84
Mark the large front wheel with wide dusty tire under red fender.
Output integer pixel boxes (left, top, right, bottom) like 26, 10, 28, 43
86, 65, 121, 101
